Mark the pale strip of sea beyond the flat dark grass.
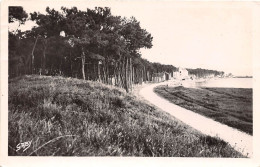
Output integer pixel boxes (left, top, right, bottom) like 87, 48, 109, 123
195, 78, 253, 88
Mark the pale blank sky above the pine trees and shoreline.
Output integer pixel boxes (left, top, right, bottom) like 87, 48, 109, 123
10, 1, 253, 75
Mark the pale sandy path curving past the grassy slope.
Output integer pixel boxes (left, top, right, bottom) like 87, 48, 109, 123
139, 82, 253, 157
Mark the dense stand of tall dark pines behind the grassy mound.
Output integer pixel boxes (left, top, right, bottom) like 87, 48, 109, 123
9, 6, 223, 91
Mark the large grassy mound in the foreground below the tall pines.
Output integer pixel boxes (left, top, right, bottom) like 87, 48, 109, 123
8, 76, 243, 157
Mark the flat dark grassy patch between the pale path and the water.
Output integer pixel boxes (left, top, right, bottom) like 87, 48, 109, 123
155, 86, 253, 135
